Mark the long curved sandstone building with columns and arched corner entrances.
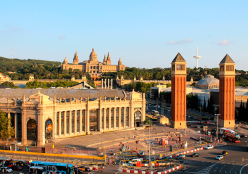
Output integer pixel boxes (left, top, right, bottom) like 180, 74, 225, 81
0, 89, 146, 146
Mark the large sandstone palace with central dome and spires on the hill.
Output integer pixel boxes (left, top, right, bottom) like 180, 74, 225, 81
61, 48, 125, 79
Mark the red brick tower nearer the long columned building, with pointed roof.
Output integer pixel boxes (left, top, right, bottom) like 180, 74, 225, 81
171, 53, 187, 129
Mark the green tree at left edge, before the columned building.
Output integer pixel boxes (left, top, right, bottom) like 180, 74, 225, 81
0, 110, 15, 140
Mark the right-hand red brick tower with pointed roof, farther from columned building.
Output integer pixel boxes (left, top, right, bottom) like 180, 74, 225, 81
219, 54, 235, 128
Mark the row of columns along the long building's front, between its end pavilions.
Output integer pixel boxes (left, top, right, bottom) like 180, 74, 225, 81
53, 107, 131, 137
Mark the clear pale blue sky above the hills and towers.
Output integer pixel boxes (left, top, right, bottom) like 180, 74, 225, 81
0, 0, 248, 71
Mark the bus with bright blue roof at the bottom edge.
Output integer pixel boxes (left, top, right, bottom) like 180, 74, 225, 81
30, 161, 74, 174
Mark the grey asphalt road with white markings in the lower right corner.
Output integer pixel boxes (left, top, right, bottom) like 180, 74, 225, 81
171, 142, 248, 174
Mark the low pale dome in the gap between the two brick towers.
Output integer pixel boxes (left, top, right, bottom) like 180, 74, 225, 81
195, 75, 219, 89
